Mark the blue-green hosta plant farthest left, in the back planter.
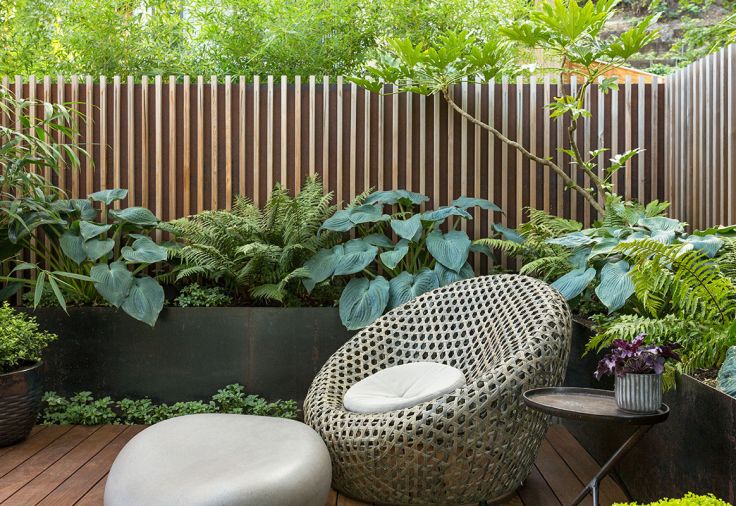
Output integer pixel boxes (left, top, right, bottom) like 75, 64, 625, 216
1, 189, 167, 326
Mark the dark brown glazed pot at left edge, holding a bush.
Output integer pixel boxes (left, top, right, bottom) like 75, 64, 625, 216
0, 362, 43, 446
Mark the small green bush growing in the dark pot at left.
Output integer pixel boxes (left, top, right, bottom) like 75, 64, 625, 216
0, 302, 57, 373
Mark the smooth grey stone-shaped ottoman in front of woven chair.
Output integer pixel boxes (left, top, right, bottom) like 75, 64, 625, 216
105, 414, 332, 506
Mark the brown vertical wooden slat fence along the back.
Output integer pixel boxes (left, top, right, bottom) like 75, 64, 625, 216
6, 76, 668, 242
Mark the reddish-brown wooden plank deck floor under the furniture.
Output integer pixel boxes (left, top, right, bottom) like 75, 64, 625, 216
0, 425, 626, 506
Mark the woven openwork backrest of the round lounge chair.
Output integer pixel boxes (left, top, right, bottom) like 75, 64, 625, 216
354, 274, 570, 380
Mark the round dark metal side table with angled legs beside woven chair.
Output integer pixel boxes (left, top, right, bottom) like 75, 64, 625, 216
524, 387, 670, 506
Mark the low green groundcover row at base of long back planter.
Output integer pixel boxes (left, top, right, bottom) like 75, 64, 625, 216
39, 384, 297, 425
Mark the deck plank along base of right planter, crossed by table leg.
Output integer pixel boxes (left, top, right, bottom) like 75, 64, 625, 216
547, 425, 628, 504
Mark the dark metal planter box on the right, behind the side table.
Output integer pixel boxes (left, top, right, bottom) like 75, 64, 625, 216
564, 323, 736, 504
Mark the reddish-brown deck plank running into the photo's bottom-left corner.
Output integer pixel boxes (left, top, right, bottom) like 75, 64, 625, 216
0, 425, 99, 502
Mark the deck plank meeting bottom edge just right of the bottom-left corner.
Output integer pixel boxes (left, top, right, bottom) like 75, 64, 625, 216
7, 425, 125, 506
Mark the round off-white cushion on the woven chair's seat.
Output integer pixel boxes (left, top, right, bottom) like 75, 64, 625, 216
342, 362, 465, 413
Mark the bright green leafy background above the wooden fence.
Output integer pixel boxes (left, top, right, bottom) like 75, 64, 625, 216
0, 0, 527, 76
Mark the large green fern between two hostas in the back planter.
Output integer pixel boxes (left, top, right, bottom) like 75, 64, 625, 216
163, 178, 339, 306
